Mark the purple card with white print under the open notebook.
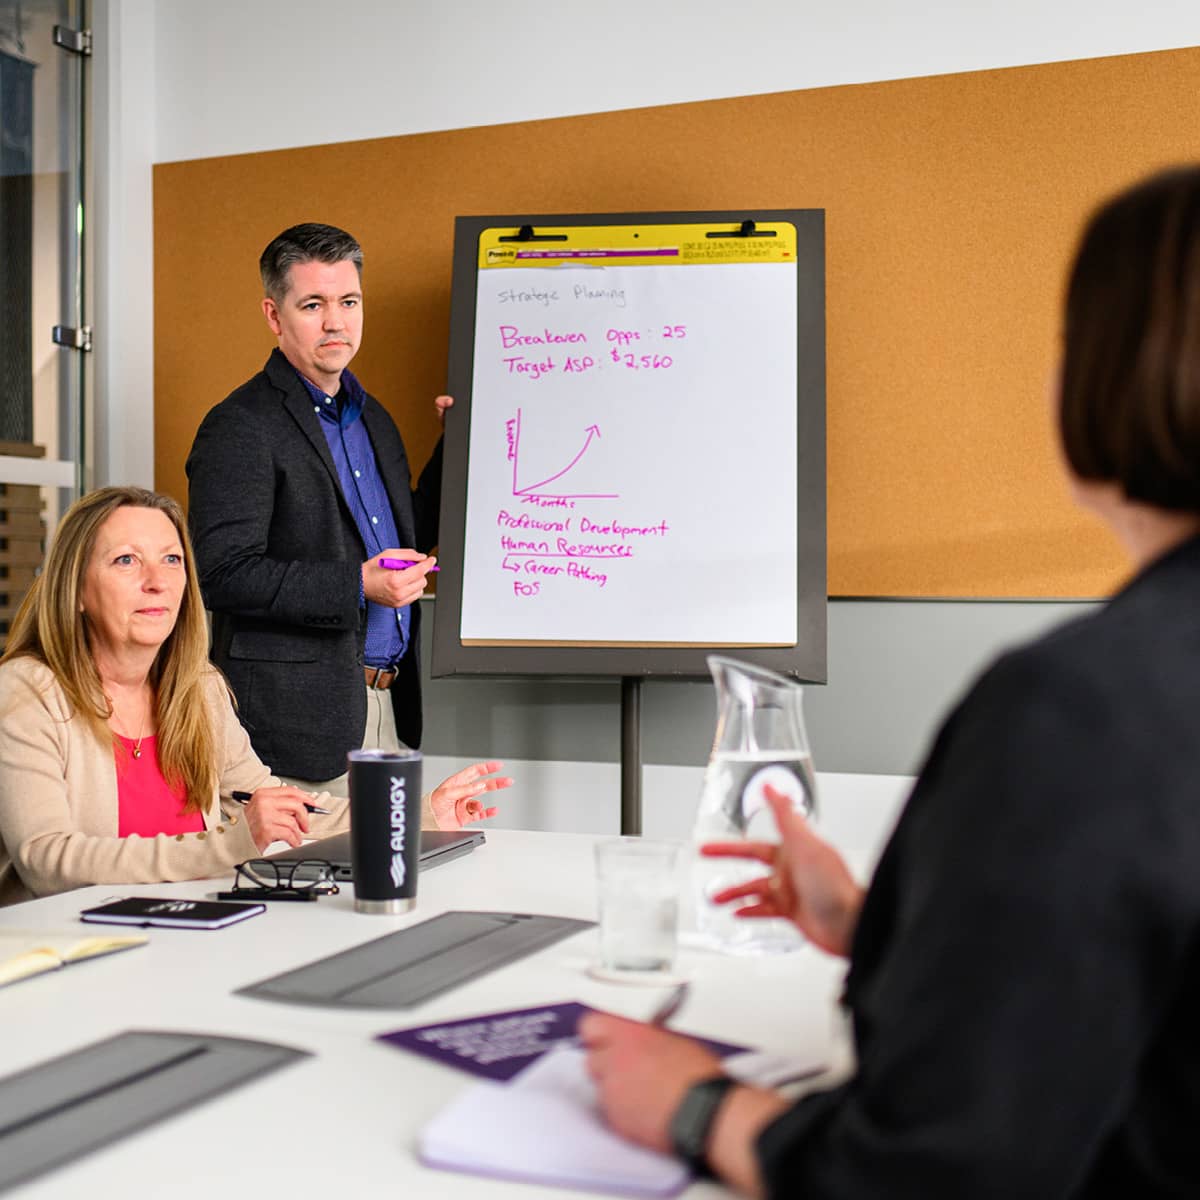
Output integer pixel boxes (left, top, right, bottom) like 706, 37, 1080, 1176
378, 1002, 743, 1082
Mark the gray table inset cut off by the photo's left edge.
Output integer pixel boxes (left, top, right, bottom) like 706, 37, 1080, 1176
0, 1030, 308, 1192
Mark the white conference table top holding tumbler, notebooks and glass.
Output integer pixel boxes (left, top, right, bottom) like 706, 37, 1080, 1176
0, 830, 864, 1200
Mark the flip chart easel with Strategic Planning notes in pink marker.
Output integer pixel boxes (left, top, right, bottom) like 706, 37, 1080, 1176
432, 210, 826, 833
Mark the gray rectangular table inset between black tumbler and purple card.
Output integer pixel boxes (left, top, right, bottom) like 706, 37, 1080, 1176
239, 912, 595, 1008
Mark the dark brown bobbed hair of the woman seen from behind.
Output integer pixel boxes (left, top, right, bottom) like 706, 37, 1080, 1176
1058, 167, 1200, 512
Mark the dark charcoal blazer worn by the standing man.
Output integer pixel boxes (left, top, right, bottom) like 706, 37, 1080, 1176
187, 350, 442, 780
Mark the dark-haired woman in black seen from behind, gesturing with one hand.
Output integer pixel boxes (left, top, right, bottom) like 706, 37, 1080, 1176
582, 167, 1200, 1200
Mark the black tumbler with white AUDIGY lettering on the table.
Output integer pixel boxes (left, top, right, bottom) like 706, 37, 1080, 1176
347, 750, 421, 913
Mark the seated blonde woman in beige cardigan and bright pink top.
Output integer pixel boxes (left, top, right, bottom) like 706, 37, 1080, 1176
0, 487, 512, 905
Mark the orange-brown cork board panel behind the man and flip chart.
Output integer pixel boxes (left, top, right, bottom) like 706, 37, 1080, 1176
154, 48, 1200, 598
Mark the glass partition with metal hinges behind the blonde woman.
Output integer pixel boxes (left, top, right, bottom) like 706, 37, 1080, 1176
0, 0, 89, 644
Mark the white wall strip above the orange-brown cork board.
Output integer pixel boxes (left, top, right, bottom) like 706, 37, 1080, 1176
155, 0, 1200, 162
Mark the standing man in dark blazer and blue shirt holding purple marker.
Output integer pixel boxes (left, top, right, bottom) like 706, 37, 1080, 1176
187, 224, 452, 792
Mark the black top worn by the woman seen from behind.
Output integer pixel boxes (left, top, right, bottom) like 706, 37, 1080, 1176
758, 540, 1200, 1200
